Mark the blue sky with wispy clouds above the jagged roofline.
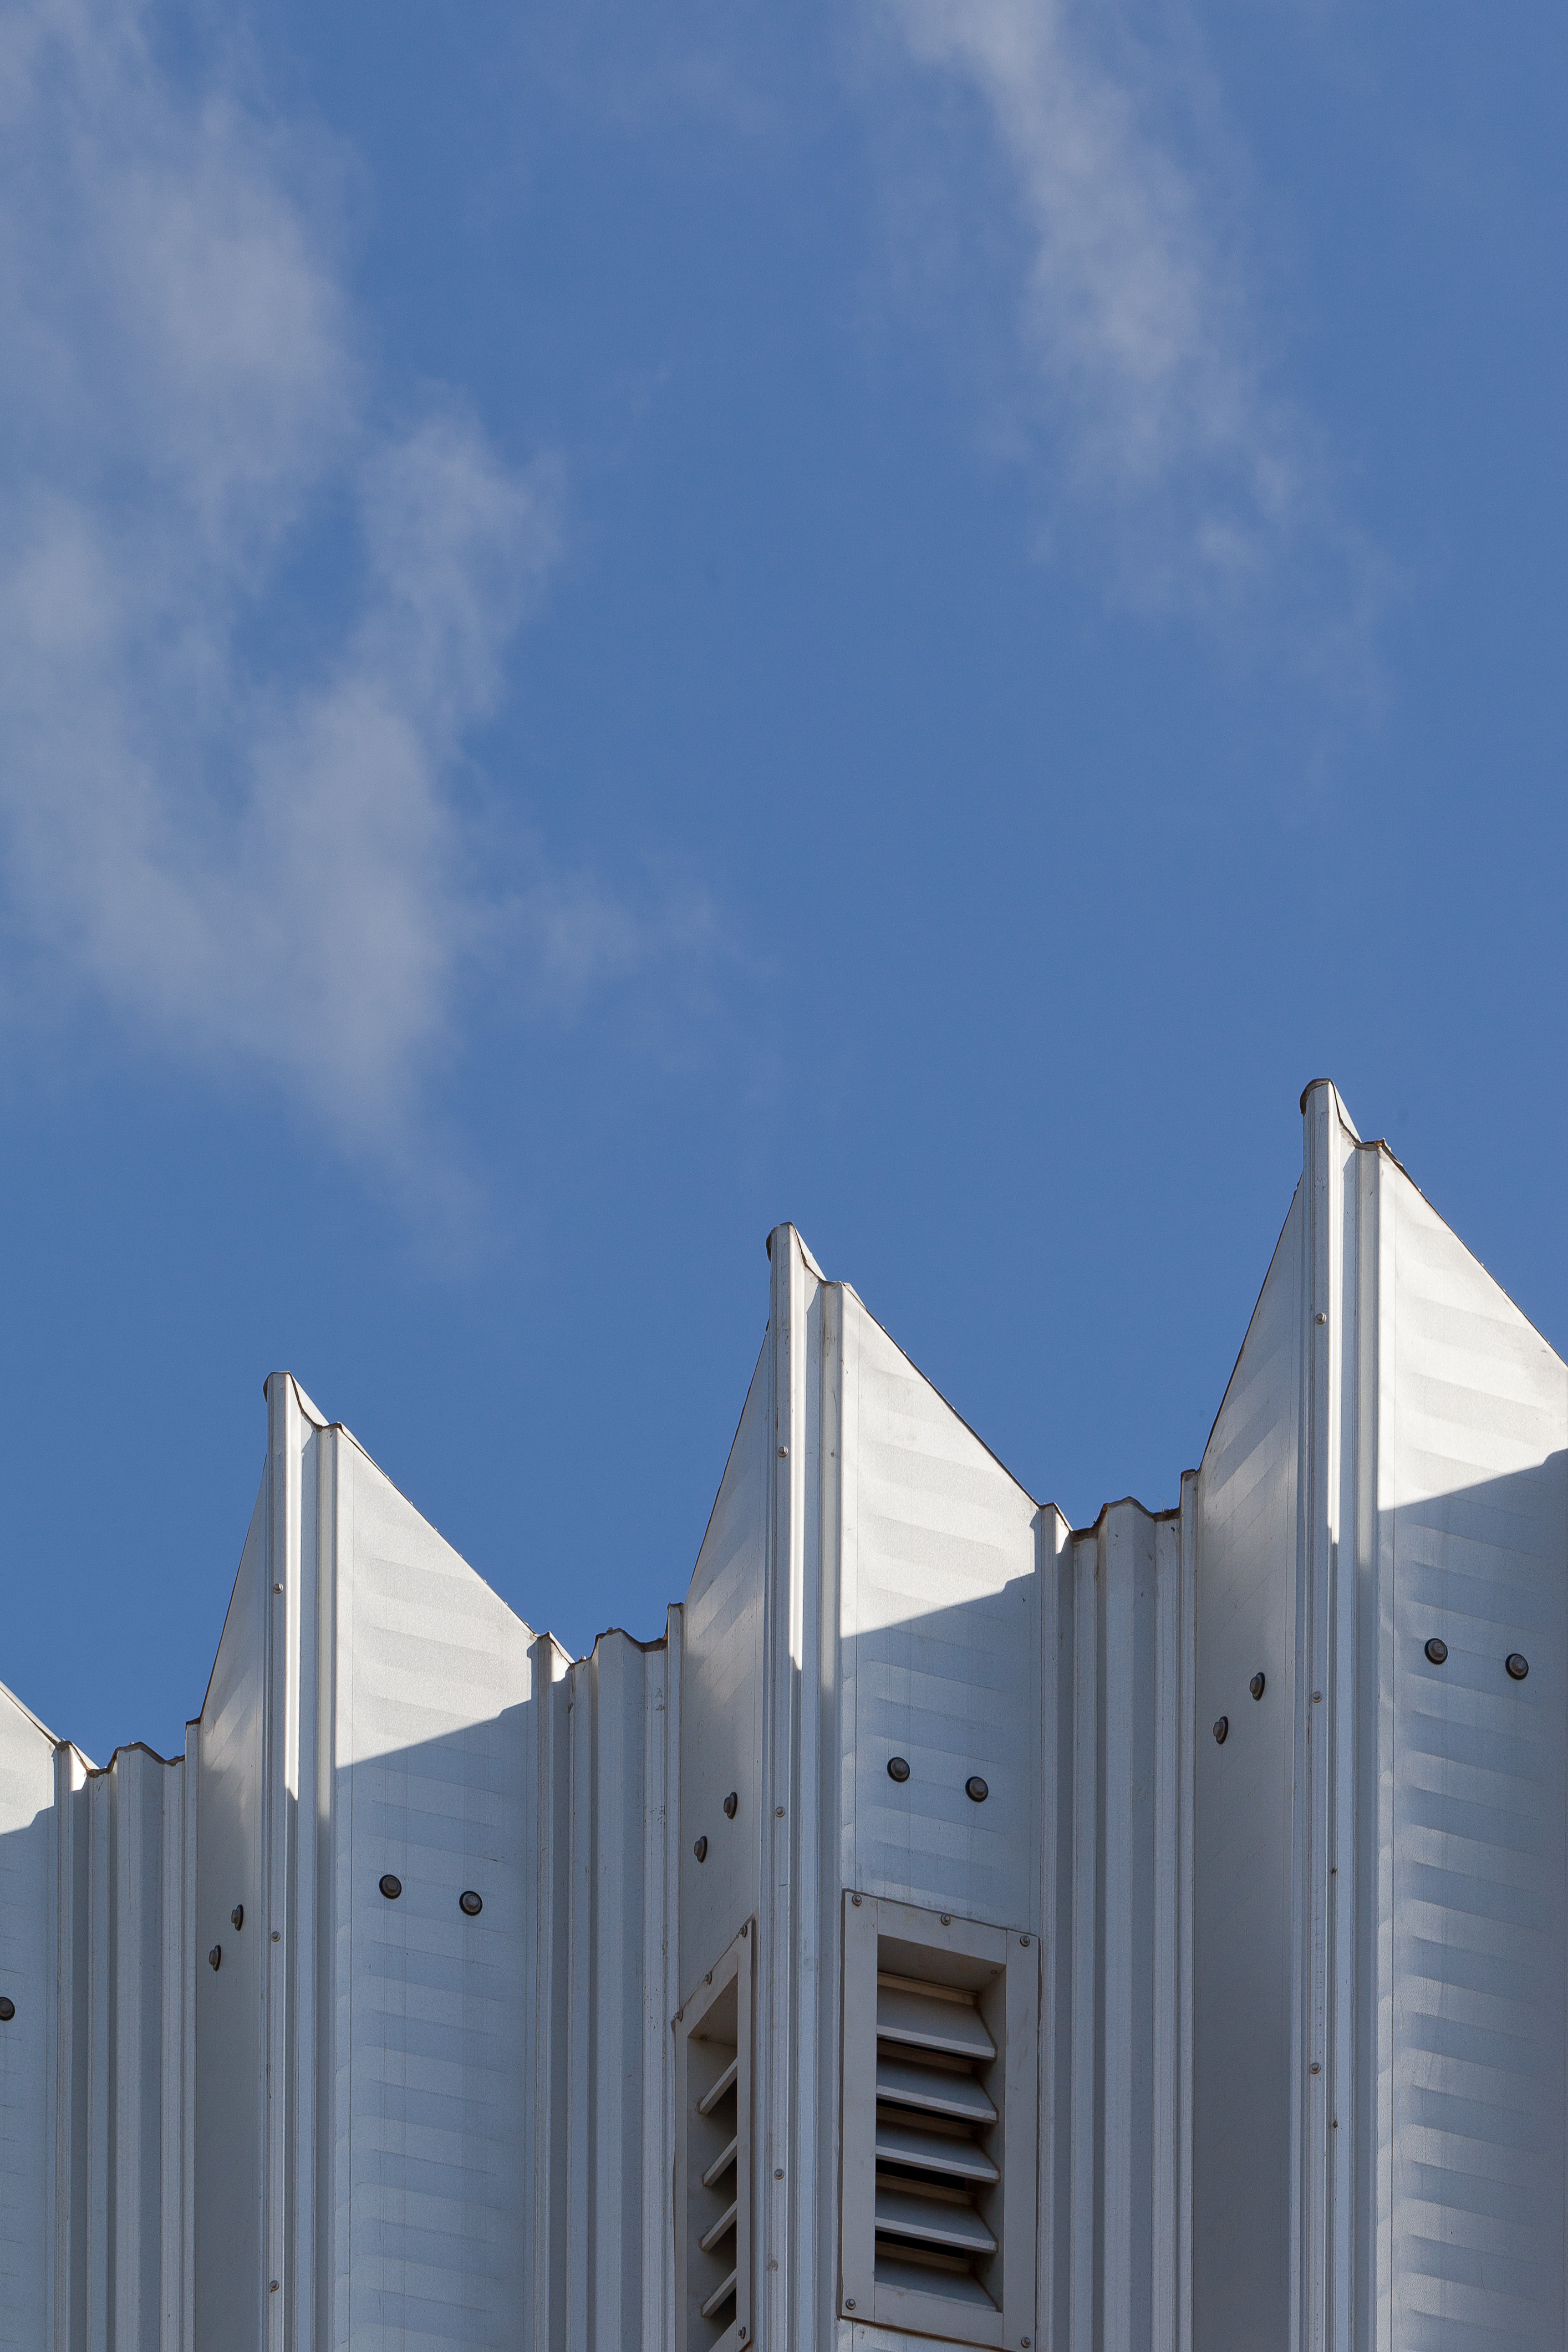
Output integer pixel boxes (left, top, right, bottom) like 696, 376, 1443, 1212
0, 0, 1568, 1757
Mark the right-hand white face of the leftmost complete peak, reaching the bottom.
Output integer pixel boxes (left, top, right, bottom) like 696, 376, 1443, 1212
334, 1432, 533, 2352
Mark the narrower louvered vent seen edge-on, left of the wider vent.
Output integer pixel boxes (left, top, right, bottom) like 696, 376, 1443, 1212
675, 1924, 752, 2352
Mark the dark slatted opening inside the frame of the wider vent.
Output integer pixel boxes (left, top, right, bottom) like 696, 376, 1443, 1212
874, 1969, 1001, 2310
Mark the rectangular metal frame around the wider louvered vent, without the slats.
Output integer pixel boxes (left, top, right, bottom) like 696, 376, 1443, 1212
839, 1891, 1041, 2352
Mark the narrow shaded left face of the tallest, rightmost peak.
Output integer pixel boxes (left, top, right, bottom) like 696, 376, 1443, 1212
1192, 1190, 1302, 2352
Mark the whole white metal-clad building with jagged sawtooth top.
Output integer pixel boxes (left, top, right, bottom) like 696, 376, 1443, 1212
0, 1082, 1568, 2352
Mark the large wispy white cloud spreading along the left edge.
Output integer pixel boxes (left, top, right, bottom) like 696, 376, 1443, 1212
0, 0, 691, 1159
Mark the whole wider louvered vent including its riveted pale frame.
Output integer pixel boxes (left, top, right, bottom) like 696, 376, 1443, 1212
839, 1896, 1039, 2352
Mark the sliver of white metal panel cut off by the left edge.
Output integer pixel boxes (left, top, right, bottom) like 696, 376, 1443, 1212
0, 1687, 54, 2352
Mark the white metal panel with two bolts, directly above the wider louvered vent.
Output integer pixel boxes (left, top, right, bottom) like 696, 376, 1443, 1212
842, 1291, 1041, 1926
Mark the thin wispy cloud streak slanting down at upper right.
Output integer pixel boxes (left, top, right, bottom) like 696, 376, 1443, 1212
879, 0, 1371, 639
